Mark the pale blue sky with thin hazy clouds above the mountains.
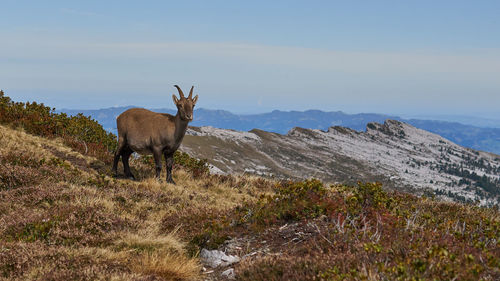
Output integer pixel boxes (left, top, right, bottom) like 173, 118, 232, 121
0, 0, 500, 118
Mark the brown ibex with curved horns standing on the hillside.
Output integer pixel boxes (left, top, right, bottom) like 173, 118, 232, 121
113, 85, 198, 184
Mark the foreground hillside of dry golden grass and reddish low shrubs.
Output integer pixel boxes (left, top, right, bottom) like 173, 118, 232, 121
0, 91, 500, 280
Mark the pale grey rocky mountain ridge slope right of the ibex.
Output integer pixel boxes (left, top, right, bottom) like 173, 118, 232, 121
182, 120, 500, 205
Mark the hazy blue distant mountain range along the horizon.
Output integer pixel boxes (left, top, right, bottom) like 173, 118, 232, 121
61, 106, 500, 154
